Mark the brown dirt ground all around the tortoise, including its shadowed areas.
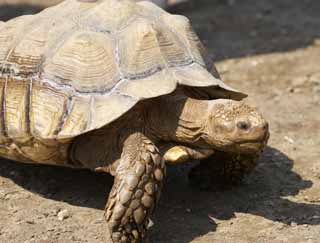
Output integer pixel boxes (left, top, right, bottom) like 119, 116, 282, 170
0, 0, 320, 243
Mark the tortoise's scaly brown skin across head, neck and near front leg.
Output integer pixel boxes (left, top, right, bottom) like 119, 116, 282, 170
70, 92, 268, 243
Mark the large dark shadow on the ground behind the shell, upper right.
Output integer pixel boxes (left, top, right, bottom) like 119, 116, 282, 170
172, 0, 320, 61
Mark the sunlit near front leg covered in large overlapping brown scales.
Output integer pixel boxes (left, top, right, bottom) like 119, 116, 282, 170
106, 133, 165, 243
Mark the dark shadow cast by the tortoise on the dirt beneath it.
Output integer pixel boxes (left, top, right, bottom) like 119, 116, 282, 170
0, 147, 320, 243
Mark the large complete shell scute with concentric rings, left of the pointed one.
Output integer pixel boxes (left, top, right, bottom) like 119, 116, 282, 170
43, 32, 119, 92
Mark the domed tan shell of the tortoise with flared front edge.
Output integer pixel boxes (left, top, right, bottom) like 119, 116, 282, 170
0, 0, 245, 140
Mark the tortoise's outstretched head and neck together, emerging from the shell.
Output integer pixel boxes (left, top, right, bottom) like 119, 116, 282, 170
146, 95, 269, 154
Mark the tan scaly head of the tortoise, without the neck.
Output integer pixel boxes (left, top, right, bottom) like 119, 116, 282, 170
202, 100, 269, 153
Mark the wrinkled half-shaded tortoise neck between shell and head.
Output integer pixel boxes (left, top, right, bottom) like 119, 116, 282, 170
146, 95, 209, 144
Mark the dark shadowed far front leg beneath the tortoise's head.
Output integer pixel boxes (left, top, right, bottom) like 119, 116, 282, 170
189, 151, 259, 189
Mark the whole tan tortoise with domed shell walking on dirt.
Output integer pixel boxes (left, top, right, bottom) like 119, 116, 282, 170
0, 0, 269, 242
